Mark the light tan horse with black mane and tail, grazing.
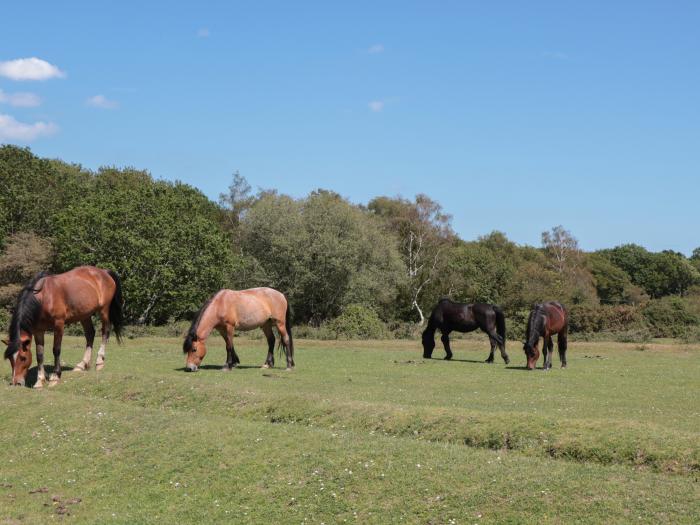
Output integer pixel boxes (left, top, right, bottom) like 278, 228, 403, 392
182, 288, 294, 372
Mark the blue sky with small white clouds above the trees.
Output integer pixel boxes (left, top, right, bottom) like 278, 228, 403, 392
0, 1, 700, 254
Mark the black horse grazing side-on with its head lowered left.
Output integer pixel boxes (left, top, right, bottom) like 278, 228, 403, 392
423, 299, 510, 364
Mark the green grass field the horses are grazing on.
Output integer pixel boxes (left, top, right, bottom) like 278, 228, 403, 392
0, 337, 700, 524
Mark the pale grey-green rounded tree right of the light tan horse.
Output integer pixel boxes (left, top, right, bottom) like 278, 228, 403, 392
242, 190, 403, 324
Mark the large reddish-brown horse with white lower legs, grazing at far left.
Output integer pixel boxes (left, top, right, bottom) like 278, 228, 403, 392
4, 266, 124, 388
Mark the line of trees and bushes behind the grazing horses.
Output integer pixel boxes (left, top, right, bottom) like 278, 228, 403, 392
0, 146, 700, 338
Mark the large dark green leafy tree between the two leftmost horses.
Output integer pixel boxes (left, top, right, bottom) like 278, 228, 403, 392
55, 168, 236, 323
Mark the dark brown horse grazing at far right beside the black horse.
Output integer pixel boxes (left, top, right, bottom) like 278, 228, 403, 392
523, 301, 569, 370
